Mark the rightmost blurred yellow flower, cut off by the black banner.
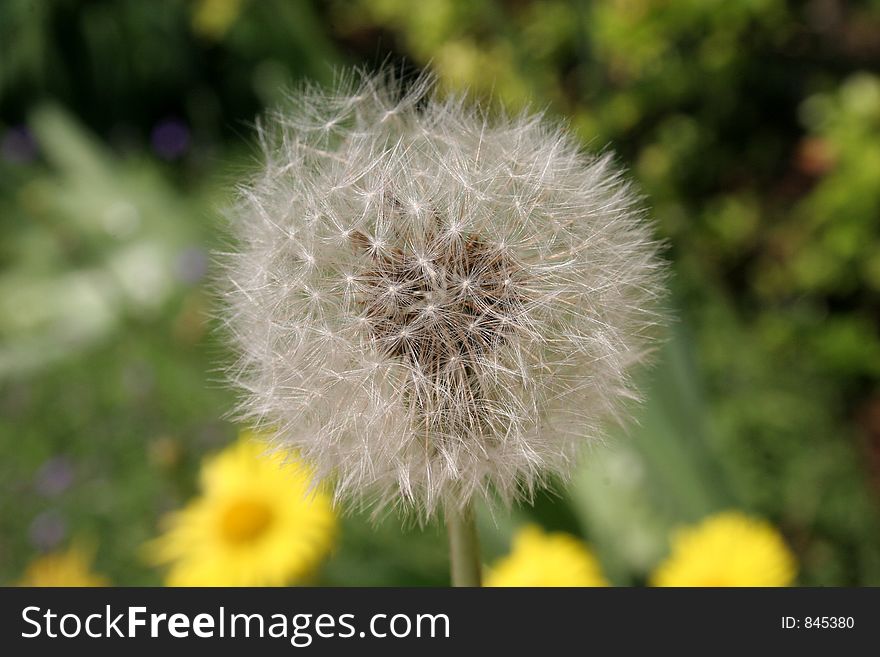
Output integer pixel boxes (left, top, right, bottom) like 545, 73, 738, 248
651, 511, 797, 586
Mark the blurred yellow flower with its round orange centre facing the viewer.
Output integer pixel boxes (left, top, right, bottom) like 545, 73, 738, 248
147, 433, 336, 586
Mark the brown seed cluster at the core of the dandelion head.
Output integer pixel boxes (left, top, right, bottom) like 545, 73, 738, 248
352, 214, 526, 434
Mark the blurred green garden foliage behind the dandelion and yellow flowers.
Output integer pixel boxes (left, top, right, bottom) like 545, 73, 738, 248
0, 0, 880, 585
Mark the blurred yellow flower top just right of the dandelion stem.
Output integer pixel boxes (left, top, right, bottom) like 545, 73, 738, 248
485, 525, 608, 586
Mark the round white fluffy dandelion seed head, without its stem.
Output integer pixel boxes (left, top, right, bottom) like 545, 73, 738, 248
224, 69, 664, 518
